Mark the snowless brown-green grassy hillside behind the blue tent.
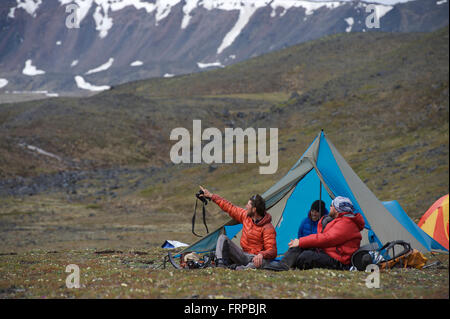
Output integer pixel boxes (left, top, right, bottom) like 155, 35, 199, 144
0, 28, 449, 224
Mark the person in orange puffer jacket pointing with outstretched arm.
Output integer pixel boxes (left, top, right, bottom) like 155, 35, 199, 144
200, 187, 277, 269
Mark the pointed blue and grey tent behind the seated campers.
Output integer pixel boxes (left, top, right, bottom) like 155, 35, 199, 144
183, 131, 446, 255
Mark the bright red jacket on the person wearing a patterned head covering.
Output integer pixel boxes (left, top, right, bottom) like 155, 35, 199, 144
299, 213, 365, 265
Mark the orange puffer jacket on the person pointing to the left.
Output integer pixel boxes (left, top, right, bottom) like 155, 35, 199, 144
211, 194, 277, 259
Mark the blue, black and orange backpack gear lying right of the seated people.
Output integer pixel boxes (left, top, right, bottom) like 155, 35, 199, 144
351, 240, 427, 271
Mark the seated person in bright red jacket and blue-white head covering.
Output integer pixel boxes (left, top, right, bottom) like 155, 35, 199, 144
281, 196, 365, 270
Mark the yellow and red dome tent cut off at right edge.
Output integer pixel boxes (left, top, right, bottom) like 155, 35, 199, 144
418, 194, 448, 250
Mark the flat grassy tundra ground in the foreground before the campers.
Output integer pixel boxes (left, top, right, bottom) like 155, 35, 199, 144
0, 248, 449, 299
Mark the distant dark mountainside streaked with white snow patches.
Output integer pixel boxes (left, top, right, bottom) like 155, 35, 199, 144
0, 0, 448, 102
